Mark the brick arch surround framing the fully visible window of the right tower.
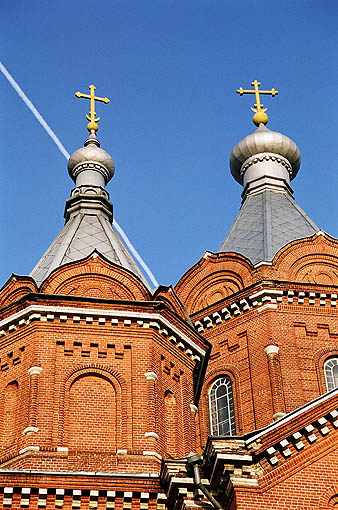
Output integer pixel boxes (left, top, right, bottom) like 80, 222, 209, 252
199, 365, 243, 441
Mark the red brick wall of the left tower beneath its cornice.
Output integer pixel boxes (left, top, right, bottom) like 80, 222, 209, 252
0, 292, 203, 471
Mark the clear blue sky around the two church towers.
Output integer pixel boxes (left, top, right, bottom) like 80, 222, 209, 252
0, 0, 338, 284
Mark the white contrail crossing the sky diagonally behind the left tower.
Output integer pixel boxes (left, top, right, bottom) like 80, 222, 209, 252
0, 62, 158, 287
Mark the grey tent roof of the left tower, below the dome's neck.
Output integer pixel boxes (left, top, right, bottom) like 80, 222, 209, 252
30, 211, 149, 288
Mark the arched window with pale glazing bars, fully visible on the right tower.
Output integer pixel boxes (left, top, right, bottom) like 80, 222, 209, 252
209, 375, 236, 436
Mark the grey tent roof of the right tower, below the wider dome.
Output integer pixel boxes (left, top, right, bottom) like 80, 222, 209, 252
219, 190, 319, 264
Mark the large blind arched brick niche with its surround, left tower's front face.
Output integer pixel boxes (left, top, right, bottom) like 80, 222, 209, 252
58, 366, 127, 453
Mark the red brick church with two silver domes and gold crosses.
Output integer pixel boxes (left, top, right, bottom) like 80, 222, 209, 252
0, 80, 338, 510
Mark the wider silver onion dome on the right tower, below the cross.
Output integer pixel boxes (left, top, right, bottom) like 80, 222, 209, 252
230, 124, 300, 184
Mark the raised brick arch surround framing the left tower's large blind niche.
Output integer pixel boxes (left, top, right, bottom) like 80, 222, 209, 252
58, 364, 128, 448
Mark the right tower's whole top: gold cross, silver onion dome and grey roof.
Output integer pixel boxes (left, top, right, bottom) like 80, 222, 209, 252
219, 80, 318, 265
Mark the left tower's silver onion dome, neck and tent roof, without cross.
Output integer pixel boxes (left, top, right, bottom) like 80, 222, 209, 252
30, 131, 150, 289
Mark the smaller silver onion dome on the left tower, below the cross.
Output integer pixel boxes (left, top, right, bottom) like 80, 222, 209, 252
68, 131, 115, 185
